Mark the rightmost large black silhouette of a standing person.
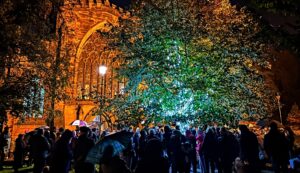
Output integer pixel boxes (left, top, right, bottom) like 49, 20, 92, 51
264, 122, 289, 173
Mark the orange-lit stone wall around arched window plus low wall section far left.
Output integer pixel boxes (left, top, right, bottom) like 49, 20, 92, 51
7, 0, 124, 151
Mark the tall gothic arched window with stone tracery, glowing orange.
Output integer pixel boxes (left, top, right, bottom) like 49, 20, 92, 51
77, 33, 122, 100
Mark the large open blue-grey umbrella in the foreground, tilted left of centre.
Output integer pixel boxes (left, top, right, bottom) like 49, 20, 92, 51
86, 131, 133, 164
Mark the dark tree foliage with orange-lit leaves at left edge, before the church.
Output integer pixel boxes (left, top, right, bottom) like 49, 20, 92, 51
0, 0, 69, 124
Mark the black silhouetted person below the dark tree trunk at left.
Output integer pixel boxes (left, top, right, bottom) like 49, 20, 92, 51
50, 130, 73, 173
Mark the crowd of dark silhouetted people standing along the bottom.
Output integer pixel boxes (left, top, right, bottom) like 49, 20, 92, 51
0, 123, 295, 173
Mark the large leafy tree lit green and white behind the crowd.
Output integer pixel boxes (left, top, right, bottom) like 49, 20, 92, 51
103, 0, 274, 127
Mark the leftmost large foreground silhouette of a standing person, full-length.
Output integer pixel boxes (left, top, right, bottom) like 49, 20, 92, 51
29, 129, 50, 173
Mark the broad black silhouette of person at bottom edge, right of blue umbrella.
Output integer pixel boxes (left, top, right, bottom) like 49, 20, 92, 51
135, 138, 169, 173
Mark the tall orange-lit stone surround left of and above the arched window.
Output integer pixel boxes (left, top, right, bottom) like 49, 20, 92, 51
61, 0, 123, 129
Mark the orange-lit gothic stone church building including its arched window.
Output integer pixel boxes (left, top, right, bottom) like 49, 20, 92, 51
7, 0, 128, 149
